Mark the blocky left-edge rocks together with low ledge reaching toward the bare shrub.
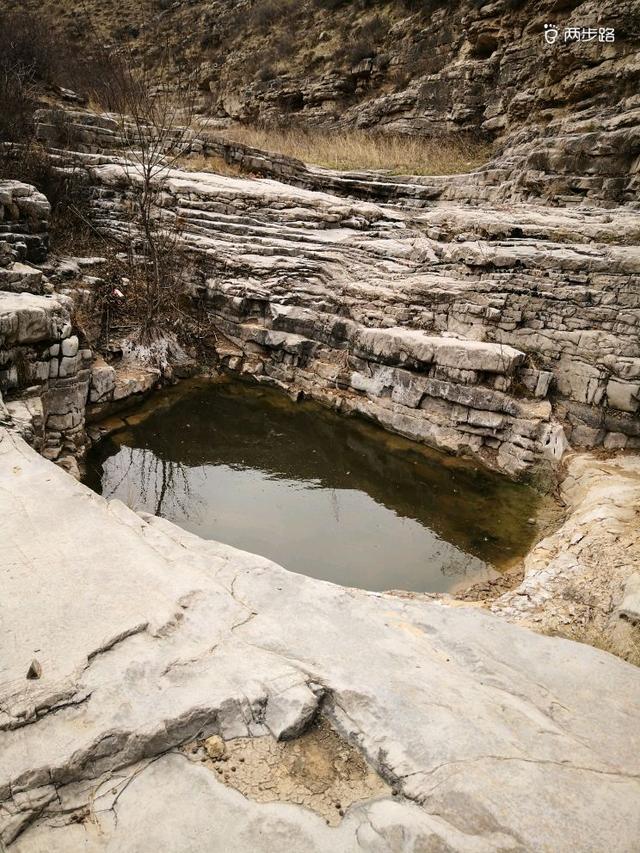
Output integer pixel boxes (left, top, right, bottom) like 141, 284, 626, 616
0, 181, 168, 476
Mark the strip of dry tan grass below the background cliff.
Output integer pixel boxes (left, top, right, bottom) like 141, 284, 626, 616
214, 125, 491, 175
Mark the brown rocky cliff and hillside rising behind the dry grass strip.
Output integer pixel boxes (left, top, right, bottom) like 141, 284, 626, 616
6, 0, 640, 204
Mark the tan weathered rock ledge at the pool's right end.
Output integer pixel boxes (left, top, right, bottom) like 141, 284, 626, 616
490, 454, 640, 663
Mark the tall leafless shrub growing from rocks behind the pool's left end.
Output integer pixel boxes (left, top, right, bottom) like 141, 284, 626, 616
80, 37, 205, 347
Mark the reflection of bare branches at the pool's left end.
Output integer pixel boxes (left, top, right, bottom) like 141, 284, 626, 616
104, 445, 202, 518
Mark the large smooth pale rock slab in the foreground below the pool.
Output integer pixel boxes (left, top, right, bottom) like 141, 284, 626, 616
0, 433, 640, 853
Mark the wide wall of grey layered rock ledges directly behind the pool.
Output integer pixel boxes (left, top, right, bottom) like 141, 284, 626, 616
43, 154, 640, 476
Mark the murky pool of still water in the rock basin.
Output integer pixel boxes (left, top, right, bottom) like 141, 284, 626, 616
85, 380, 539, 592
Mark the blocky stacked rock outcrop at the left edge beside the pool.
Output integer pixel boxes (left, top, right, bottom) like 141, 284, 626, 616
0, 181, 92, 471
